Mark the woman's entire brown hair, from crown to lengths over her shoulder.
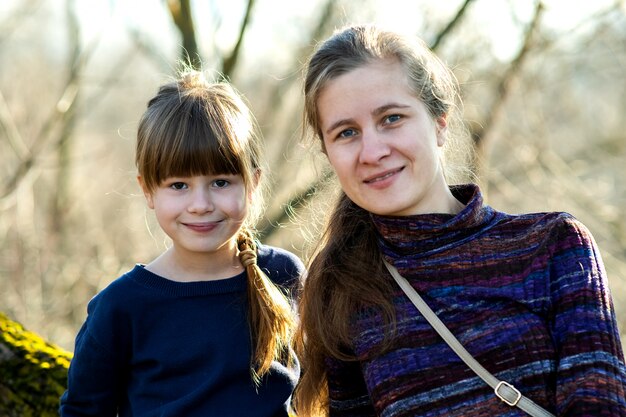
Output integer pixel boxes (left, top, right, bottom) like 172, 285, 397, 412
294, 26, 471, 416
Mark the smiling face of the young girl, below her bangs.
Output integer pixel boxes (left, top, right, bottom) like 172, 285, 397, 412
140, 174, 249, 260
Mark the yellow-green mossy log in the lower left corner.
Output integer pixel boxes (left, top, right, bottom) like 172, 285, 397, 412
0, 313, 72, 417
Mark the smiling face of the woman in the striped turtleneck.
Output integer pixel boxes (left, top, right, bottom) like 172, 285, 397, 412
317, 61, 450, 216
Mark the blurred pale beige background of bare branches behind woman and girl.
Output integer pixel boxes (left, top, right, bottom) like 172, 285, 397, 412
0, 0, 626, 350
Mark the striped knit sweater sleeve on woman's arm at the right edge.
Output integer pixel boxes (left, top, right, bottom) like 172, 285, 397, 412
549, 215, 626, 417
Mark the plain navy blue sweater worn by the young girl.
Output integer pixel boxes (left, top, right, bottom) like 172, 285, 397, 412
60, 245, 304, 417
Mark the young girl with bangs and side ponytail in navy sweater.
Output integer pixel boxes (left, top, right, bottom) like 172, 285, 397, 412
60, 72, 303, 417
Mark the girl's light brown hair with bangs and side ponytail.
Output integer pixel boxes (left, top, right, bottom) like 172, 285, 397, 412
135, 70, 295, 383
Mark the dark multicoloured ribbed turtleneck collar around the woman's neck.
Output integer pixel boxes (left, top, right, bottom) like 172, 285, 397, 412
372, 184, 499, 268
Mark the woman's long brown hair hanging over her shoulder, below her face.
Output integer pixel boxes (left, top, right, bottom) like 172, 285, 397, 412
294, 192, 395, 416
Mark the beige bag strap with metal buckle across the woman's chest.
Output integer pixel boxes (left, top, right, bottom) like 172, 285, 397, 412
383, 260, 554, 417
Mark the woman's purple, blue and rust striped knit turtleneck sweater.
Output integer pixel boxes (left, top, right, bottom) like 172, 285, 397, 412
327, 185, 626, 417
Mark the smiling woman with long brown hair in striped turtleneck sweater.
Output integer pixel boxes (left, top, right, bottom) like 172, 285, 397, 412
295, 26, 626, 417
